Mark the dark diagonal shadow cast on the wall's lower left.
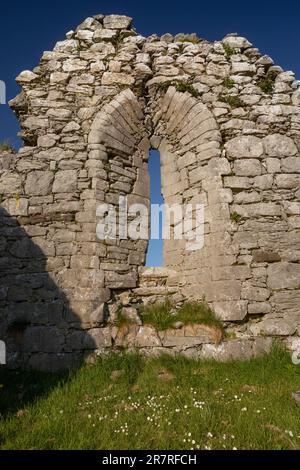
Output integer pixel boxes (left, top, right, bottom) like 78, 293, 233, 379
0, 207, 95, 371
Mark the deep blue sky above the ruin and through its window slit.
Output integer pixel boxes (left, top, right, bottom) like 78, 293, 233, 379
0, 0, 300, 265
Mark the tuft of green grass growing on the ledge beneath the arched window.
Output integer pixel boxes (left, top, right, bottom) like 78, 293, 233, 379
141, 300, 223, 331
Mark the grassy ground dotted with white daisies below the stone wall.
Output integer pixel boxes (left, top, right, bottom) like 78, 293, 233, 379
0, 349, 300, 450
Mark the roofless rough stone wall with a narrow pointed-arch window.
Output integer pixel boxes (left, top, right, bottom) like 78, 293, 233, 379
0, 15, 300, 370
